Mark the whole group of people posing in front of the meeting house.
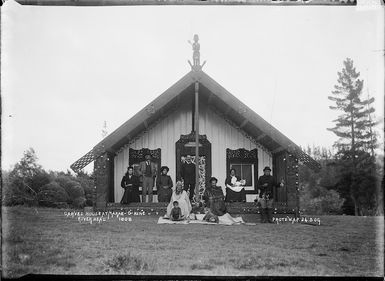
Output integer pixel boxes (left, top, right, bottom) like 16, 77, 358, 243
121, 154, 284, 222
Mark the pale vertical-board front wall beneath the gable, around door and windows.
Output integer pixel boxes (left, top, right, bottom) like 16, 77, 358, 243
114, 103, 272, 202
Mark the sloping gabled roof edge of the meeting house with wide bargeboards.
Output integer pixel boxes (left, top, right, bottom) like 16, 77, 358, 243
71, 70, 321, 172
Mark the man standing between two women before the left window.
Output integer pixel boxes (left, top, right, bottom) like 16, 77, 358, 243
139, 153, 157, 203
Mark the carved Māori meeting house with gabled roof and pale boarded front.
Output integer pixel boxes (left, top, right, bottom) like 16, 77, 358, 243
71, 63, 319, 212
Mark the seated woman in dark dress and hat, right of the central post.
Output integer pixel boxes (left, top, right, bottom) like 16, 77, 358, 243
203, 177, 227, 216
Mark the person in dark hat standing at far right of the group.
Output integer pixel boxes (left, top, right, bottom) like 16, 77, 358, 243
257, 166, 283, 223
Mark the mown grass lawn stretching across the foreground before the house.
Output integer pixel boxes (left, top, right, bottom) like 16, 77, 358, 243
2, 207, 384, 277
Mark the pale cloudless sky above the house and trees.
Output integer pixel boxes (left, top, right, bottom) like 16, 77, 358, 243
1, 0, 384, 171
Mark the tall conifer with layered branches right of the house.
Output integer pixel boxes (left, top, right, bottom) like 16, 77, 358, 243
328, 58, 376, 215
